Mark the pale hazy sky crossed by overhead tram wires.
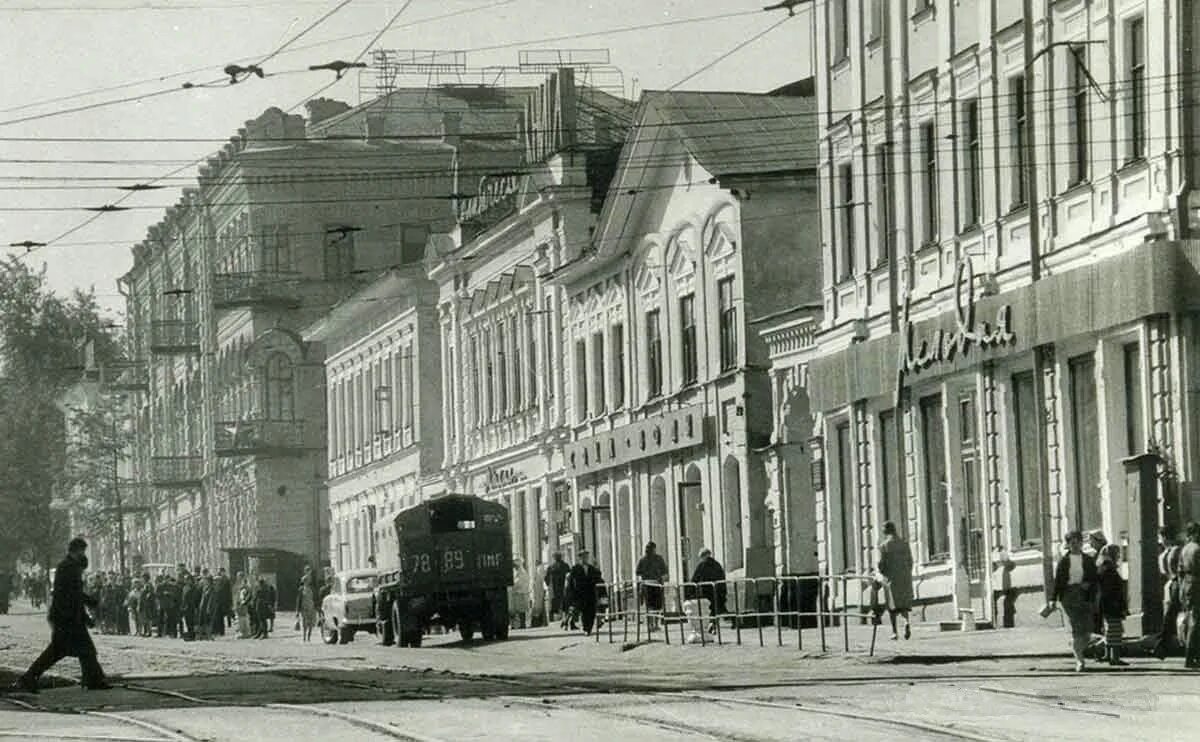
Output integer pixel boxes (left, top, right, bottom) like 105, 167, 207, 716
0, 0, 810, 313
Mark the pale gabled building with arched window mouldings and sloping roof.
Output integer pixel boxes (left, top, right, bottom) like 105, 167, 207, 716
553, 86, 820, 580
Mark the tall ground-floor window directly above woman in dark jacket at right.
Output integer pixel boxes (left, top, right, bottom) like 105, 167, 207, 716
1067, 353, 1104, 531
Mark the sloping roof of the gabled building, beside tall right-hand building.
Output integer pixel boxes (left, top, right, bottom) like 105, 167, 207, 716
646, 91, 817, 176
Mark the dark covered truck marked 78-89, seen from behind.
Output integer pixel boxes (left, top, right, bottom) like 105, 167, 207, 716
374, 495, 512, 647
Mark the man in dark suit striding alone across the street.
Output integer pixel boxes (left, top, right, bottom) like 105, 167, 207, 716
14, 538, 112, 693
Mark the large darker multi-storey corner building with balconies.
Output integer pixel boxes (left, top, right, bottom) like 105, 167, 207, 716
121, 101, 452, 587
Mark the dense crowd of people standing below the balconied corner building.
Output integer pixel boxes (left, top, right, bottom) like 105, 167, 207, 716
78, 564, 276, 641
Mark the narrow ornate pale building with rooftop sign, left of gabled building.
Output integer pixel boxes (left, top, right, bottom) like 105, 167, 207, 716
430, 68, 632, 585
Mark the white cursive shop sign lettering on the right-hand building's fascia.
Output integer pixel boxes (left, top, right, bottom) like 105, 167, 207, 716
896, 261, 1016, 396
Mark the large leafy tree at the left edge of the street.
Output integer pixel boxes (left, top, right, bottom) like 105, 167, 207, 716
0, 257, 120, 566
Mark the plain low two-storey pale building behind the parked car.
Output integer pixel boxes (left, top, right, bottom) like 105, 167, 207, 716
304, 264, 443, 570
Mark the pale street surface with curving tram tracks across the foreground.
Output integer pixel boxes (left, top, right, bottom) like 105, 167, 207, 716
0, 600, 1200, 742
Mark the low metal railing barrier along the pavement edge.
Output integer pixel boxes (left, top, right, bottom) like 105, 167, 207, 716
594, 574, 878, 656
